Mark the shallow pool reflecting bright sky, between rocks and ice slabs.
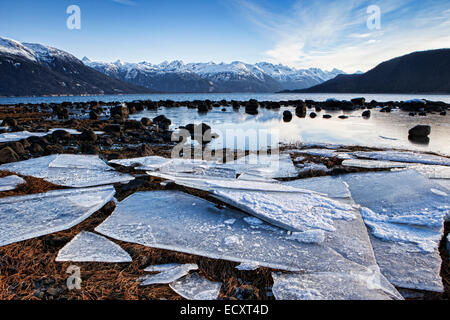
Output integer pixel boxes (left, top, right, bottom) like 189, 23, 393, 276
132, 107, 450, 155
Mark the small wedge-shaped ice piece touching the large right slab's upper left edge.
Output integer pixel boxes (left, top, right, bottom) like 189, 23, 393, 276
283, 176, 351, 198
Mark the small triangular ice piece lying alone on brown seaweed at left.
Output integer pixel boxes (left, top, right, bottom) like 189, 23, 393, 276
56, 231, 133, 263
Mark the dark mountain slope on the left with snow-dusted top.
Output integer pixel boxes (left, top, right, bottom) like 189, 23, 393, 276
0, 38, 152, 96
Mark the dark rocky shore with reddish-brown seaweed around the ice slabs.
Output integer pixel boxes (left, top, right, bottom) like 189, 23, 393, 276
0, 99, 450, 300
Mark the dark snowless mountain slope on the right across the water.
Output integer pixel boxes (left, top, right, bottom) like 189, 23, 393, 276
289, 49, 450, 94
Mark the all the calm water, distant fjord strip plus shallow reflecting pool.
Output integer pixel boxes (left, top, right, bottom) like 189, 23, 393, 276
0, 94, 450, 156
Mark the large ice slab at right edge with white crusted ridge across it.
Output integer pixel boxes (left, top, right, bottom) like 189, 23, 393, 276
343, 170, 450, 291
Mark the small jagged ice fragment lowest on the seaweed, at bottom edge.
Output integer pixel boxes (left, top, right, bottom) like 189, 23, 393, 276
169, 273, 222, 301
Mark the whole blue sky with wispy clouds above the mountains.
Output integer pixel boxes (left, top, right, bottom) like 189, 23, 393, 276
0, 0, 450, 72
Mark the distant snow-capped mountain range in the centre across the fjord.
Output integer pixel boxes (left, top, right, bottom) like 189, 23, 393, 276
83, 58, 344, 92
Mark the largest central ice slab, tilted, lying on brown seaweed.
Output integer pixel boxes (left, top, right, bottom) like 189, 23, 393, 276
96, 191, 376, 272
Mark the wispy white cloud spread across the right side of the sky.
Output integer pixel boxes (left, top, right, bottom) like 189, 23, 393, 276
230, 0, 450, 72
